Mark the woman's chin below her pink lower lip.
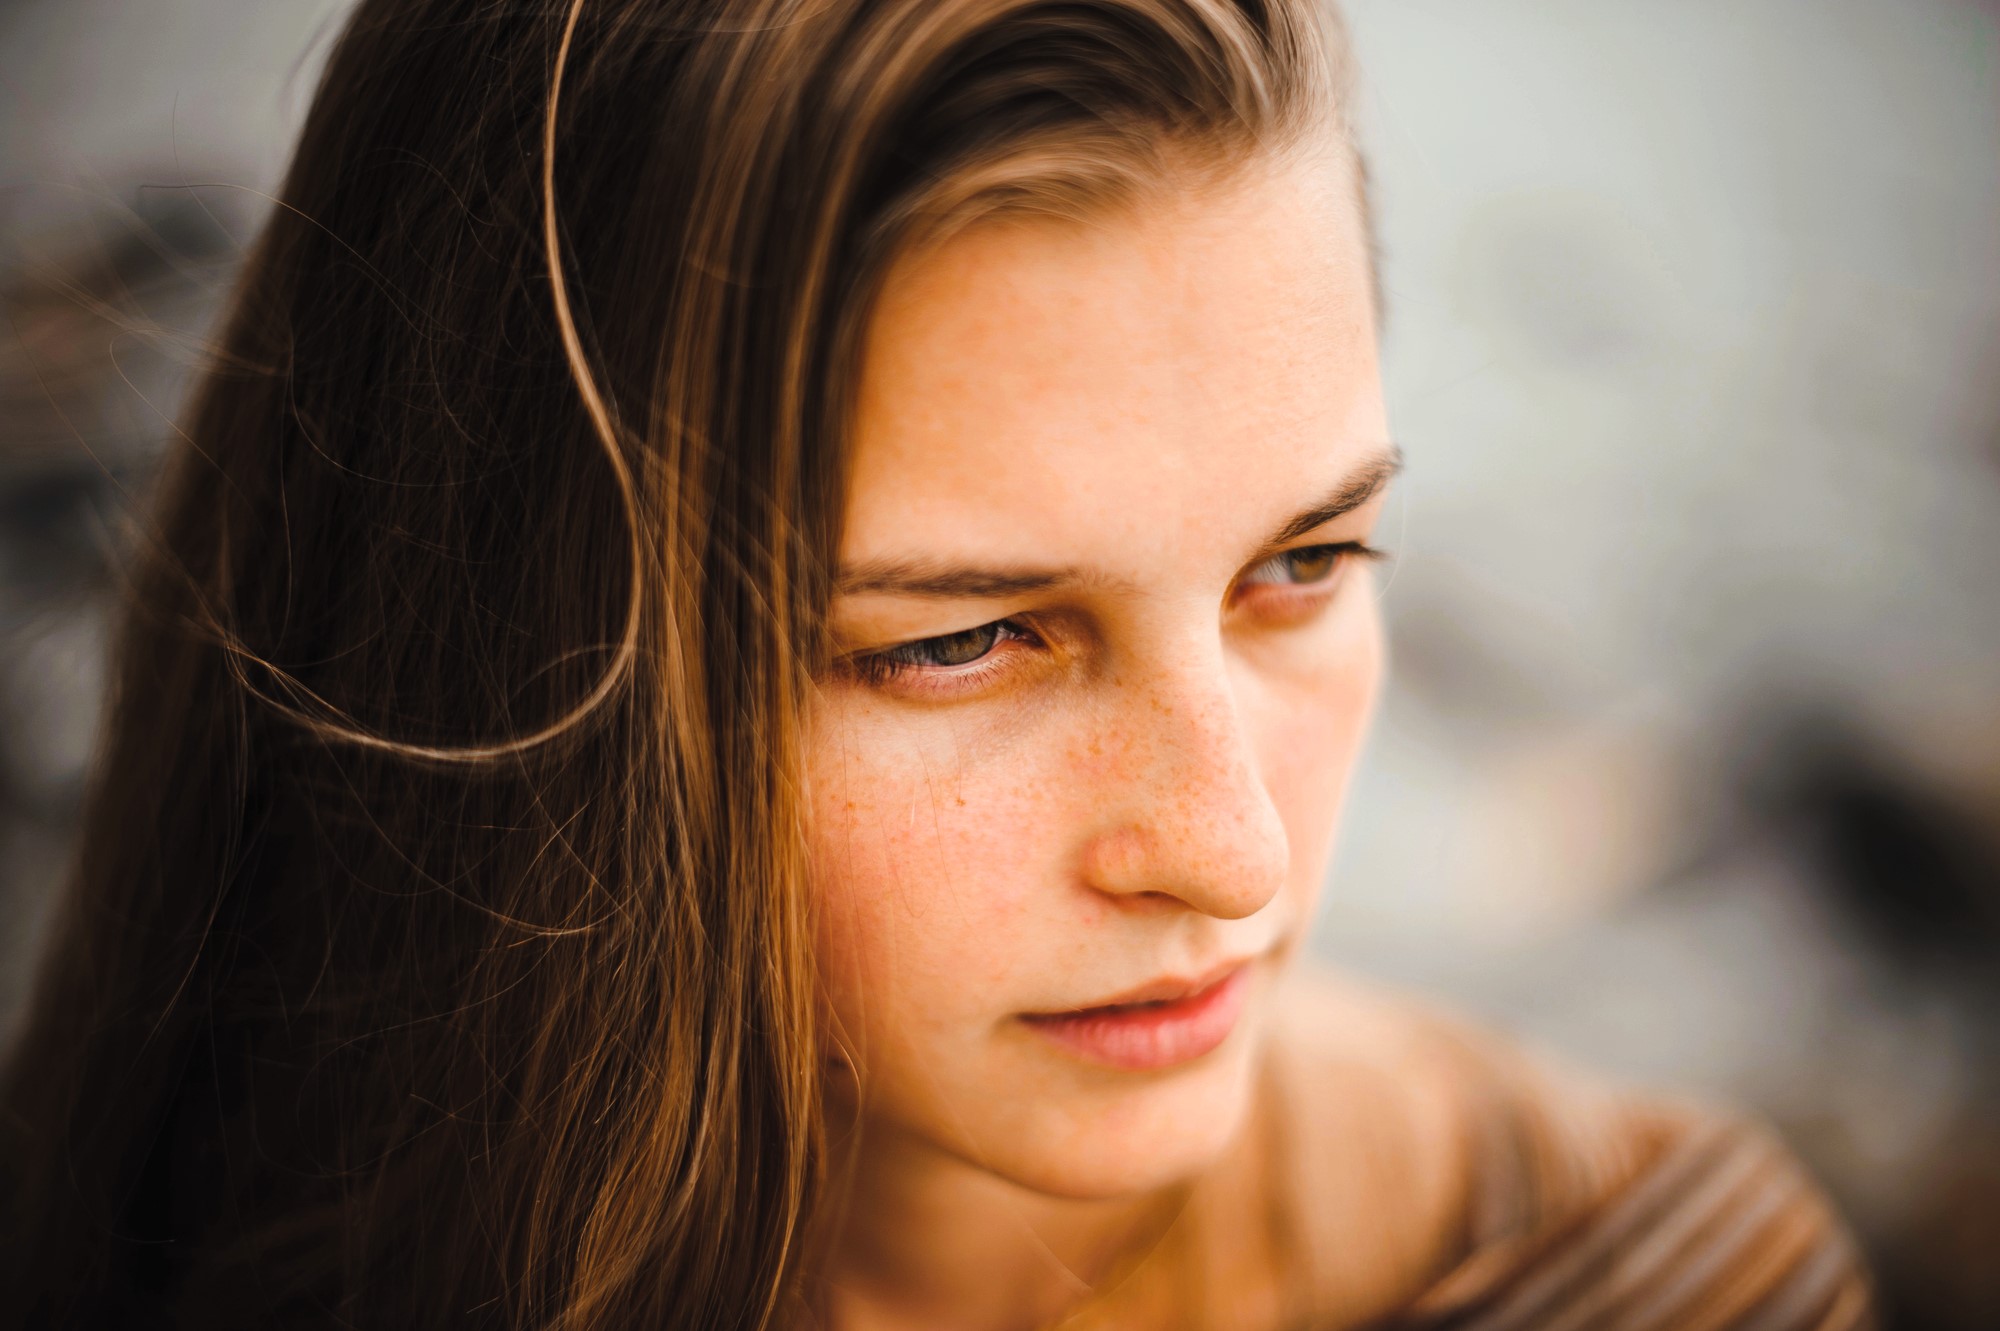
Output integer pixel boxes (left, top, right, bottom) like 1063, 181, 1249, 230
966, 1023, 1256, 1201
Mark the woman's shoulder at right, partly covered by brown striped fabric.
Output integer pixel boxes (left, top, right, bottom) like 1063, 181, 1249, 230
1274, 973, 1874, 1331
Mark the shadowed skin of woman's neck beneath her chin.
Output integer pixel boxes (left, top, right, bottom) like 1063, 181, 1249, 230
826, 1123, 1174, 1331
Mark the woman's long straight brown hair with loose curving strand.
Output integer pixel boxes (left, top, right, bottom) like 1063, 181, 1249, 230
0, 0, 1342, 1327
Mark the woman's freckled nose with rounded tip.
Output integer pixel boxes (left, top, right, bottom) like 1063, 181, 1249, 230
1084, 652, 1292, 919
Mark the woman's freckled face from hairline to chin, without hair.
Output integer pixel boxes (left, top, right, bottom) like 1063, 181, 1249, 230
808, 144, 1394, 1197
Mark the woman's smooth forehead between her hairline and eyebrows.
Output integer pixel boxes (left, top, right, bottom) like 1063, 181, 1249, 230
842, 154, 1386, 572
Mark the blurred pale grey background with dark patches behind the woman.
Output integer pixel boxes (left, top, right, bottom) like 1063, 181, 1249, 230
0, 0, 2000, 1331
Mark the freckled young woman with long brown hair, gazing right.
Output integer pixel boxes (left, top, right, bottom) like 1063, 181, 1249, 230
0, 0, 1870, 1331
